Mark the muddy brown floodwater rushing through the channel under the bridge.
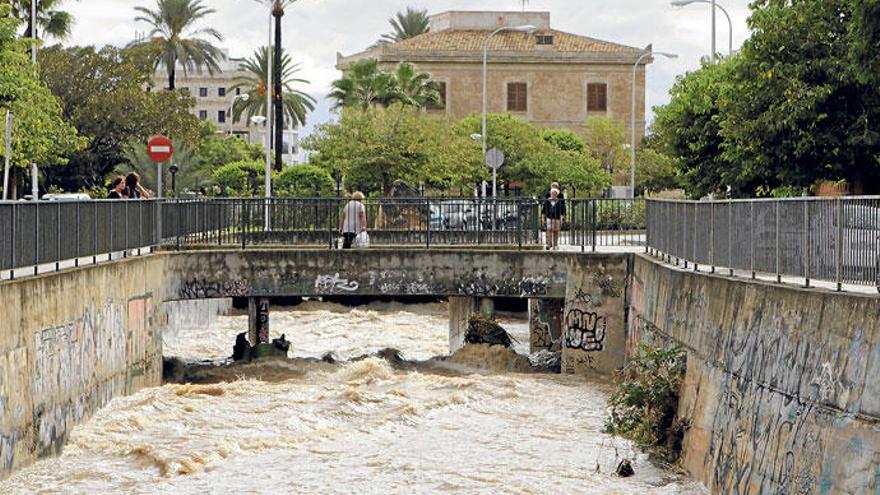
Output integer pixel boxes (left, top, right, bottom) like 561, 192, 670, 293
0, 303, 703, 494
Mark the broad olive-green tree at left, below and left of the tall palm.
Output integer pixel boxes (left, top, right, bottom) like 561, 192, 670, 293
39, 46, 201, 190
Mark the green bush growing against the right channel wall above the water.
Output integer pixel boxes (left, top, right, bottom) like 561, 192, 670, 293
605, 345, 687, 464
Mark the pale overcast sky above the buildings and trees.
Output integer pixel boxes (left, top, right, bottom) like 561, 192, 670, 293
65, 0, 748, 140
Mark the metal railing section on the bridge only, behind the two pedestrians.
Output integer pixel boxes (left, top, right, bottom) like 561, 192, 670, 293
163, 197, 645, 250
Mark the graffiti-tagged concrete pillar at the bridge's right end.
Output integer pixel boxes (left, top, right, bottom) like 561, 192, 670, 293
562, 257, 628, 374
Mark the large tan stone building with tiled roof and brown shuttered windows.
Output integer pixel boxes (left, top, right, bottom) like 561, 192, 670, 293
337, 12, 652, 137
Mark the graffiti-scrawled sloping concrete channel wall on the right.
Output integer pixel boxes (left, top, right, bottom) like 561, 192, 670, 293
627, 255, 880, 494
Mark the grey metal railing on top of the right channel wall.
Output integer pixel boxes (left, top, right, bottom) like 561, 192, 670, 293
646, 197, 880, 290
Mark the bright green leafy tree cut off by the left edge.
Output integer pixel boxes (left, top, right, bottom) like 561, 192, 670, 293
0, 4, 84, 197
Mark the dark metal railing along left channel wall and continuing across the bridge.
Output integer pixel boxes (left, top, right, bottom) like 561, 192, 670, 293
0, 197, 645, 278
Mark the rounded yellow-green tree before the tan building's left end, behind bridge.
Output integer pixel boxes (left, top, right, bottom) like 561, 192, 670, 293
303, 104, 485, 194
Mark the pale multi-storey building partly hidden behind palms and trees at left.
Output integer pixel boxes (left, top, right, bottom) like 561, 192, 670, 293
153, 53, 299, 162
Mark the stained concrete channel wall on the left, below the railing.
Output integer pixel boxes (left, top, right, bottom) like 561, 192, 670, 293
0, 255, 164, 477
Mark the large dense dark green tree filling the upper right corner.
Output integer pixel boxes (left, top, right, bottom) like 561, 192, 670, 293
655, 0, 880, 196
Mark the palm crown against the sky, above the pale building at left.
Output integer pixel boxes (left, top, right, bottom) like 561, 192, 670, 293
129, 0, 224, 90
